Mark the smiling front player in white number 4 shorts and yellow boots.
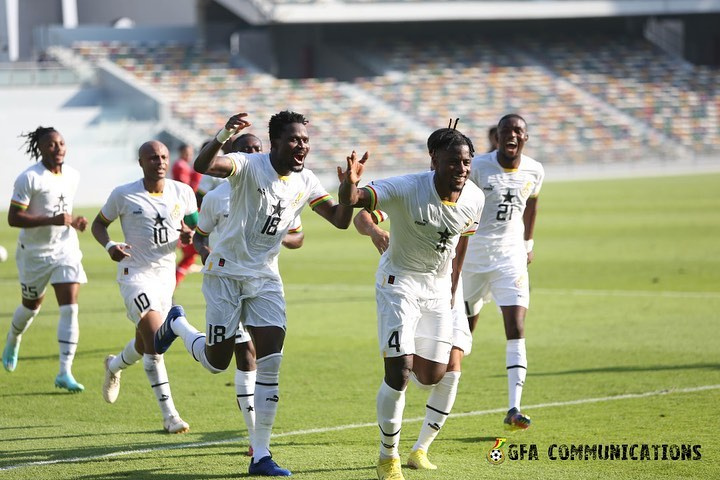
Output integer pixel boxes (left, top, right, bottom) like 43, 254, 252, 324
339, 129, 484, 480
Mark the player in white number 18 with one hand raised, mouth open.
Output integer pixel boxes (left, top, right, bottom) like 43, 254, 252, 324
155, 111, 352, 476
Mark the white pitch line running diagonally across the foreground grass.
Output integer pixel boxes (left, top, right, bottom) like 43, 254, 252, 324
0, 385, 720, 472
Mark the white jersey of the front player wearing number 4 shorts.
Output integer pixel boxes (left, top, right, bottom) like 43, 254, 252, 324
363, 171, 485, 277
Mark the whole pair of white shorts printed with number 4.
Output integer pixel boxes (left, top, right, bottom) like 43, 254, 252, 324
375, 271, 453, 363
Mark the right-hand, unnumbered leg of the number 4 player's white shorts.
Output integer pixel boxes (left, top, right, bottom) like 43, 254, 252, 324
415, 296, 454, 364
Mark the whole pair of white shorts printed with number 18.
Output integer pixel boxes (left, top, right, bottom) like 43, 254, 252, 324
202, 274, 287, 345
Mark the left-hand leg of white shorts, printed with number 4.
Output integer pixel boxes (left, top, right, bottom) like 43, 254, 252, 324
375, 283, 421, 358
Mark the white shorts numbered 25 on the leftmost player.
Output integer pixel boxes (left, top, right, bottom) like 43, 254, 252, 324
15, 248, 87, 300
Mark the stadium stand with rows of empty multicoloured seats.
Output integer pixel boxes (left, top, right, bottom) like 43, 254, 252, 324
59, 32, 720, 171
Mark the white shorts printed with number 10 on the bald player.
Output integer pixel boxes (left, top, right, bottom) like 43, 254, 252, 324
118, 272, 175, 326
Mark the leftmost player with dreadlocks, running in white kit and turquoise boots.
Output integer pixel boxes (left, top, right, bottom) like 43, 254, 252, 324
3, 127, 88, 393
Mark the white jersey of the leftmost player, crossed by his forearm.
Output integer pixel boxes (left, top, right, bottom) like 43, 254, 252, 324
10, 162, 82, 261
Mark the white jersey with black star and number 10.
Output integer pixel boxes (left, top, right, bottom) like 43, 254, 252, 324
100, 179, 197, 278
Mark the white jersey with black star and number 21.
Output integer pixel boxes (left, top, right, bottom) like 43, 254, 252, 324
464, 151, 545, 270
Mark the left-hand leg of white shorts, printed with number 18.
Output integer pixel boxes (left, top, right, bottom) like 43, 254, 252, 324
202, 274, 244, 346
